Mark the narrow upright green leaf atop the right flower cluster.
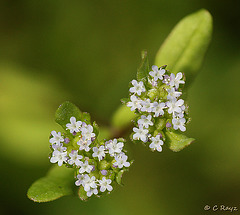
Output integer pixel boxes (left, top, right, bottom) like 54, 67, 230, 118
137, 51, 149, 83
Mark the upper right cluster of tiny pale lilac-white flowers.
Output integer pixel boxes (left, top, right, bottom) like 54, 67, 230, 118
127, 65, 187, 152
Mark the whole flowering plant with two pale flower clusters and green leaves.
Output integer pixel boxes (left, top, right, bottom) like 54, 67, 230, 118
27, 9, 212, 202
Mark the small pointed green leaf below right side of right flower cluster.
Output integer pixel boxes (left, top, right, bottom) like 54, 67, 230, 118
166, 131, 195, 152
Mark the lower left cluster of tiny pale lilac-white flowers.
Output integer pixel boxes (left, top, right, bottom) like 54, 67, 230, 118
49, 117, 130, 197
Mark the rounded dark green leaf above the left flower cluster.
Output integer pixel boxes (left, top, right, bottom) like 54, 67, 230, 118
55, 101, 83, 130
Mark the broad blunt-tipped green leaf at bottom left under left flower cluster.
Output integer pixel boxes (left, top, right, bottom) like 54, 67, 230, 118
27, 166, 74, 202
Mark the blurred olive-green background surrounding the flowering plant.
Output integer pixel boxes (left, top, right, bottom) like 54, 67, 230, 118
0, 0, 240, 215
